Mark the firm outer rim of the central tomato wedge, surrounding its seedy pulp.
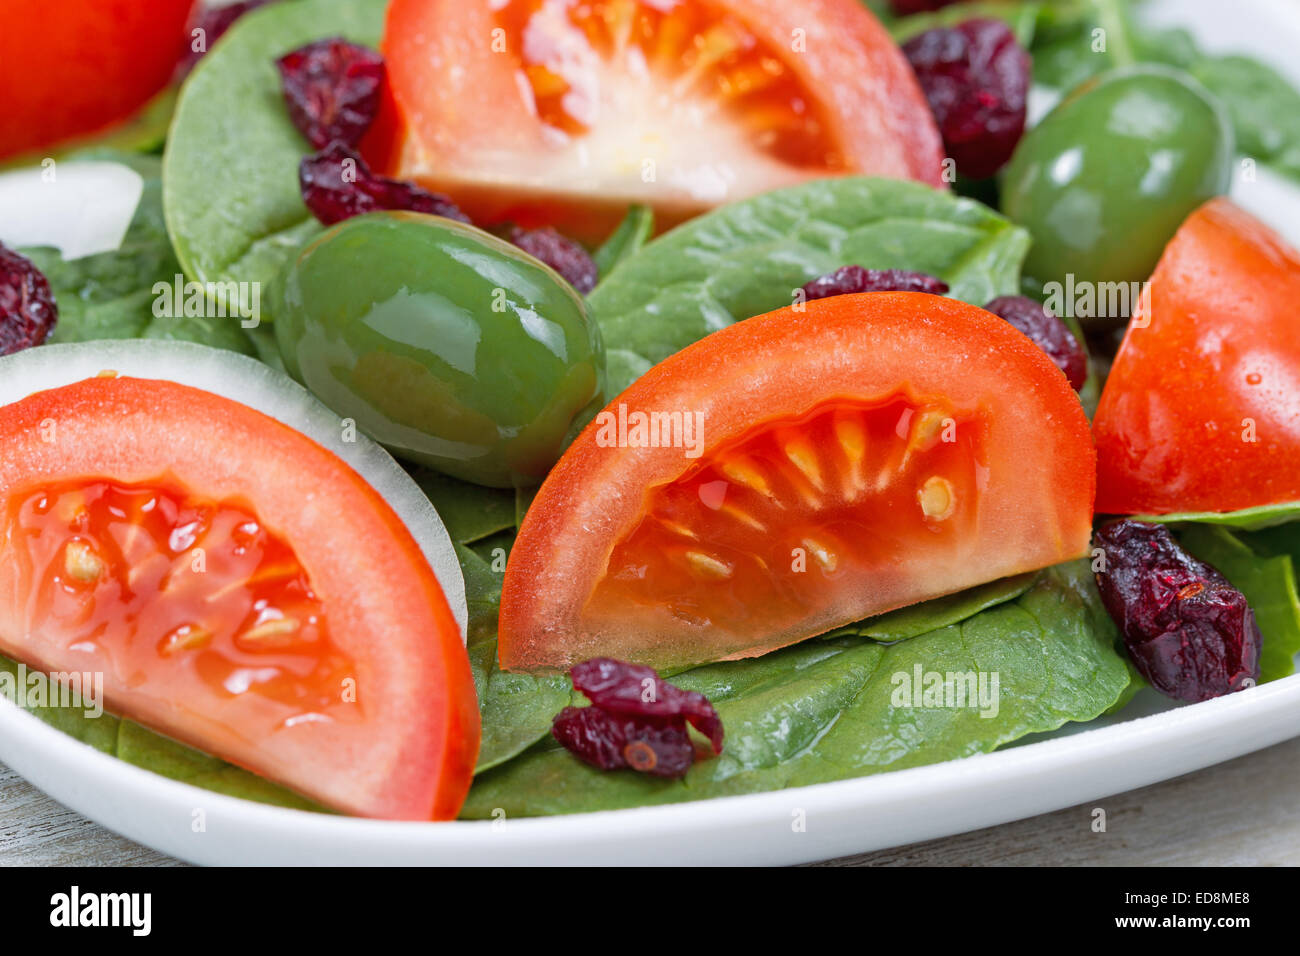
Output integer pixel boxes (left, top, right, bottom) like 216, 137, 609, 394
499, 293, 1096, 671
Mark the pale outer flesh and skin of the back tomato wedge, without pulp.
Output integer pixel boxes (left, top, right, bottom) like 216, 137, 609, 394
379, 0, 944, 241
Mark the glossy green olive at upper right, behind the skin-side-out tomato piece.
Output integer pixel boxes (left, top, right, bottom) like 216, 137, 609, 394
1002, 66, 1235, 328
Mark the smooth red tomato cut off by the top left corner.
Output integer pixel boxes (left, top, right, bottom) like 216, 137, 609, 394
0, 0, 194, 156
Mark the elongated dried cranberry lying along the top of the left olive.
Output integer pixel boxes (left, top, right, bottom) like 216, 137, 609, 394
298, 143, 469, 225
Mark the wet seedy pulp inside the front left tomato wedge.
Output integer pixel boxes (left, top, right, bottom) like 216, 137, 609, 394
8, 480, 358, 722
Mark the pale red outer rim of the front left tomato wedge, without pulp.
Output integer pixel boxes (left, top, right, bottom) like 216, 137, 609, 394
0, 377, 480, 819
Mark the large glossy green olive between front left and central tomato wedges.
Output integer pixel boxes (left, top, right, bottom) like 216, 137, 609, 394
272, 212, 605, 488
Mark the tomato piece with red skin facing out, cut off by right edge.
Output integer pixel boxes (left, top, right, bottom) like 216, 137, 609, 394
1093, 199, 1300, 514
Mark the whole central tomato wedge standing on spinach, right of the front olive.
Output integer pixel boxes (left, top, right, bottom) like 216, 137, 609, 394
499, 293, 1096, 670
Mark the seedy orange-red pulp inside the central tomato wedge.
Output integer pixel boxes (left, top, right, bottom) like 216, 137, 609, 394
590, 395, 987, 631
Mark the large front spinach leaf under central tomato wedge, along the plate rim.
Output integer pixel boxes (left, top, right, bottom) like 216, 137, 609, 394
463, 562, 1130, 818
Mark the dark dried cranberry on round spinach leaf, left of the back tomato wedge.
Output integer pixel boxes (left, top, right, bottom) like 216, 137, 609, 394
276, 36, 385, 150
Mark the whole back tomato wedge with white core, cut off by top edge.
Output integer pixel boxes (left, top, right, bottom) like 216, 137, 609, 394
377, 0, 943, 243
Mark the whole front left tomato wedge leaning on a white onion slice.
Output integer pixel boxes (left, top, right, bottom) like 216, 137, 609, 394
0, 377, 478, 819
